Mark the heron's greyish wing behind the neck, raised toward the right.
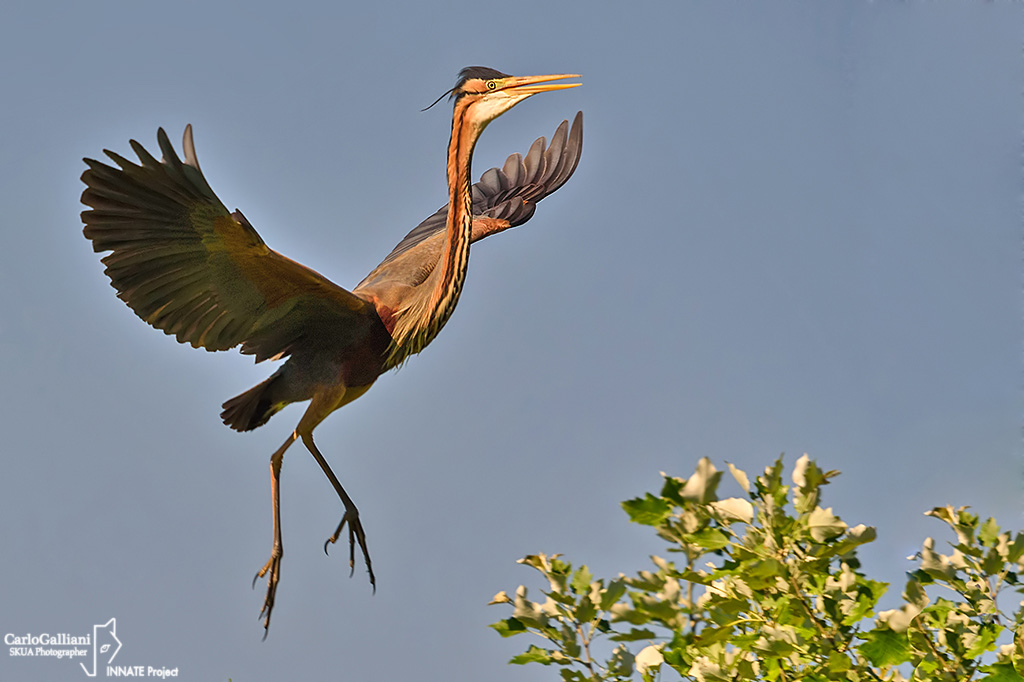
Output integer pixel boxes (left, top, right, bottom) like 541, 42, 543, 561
355, 112, 583, 292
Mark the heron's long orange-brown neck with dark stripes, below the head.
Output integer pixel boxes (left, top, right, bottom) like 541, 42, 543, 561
387, 96, 482, 367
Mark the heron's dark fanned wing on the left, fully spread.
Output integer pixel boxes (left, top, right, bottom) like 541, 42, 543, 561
82, 126, 380, 361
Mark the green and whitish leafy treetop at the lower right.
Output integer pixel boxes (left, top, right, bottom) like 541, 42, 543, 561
492, 455, 1024, 682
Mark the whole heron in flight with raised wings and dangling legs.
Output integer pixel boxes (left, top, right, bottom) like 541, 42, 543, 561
82, 67, 583, 636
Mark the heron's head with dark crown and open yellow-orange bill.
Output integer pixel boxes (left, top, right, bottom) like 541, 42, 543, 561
435, 67, 582, 133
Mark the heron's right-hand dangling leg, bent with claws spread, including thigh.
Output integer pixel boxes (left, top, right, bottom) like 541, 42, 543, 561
296, 384, 377, 592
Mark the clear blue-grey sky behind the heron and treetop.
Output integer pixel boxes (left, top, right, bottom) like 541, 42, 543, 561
0, 0, 1024, 682
